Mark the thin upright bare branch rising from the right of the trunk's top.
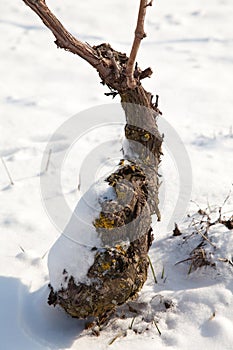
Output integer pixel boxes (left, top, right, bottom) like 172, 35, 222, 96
126, 0, 152, 89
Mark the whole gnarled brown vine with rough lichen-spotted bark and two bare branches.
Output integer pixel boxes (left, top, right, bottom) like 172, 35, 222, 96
23, 0, 162, 318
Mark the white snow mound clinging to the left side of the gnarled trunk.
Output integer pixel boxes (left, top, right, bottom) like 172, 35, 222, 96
48, 180, 113, 290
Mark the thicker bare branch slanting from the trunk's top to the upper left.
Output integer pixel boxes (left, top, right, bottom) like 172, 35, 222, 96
23, 0, 109, 77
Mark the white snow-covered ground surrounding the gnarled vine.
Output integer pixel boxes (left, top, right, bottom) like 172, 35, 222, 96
0, 0, 233, 350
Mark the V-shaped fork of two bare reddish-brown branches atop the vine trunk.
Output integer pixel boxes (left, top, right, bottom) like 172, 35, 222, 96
23, 0, 152, 90
